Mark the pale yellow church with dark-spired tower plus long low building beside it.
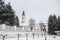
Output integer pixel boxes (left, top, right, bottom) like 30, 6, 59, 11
20, 11, 48, 31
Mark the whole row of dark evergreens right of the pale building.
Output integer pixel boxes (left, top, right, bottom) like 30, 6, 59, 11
48, 15, 60, 34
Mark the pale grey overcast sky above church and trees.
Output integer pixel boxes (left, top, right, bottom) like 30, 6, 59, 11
5, 0, 60, 22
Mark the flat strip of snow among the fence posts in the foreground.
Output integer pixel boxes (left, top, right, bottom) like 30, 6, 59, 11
0, 35, 60, 40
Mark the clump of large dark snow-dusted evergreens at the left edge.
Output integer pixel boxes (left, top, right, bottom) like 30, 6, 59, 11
0, 0, 15, 26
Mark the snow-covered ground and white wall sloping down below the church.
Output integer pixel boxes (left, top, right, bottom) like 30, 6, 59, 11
0, 26, 60, 40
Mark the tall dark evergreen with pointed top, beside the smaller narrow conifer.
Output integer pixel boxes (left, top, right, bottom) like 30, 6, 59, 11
6, 3, 15, 26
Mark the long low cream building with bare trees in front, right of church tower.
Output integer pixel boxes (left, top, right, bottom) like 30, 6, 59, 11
29, 23, 48, 32
